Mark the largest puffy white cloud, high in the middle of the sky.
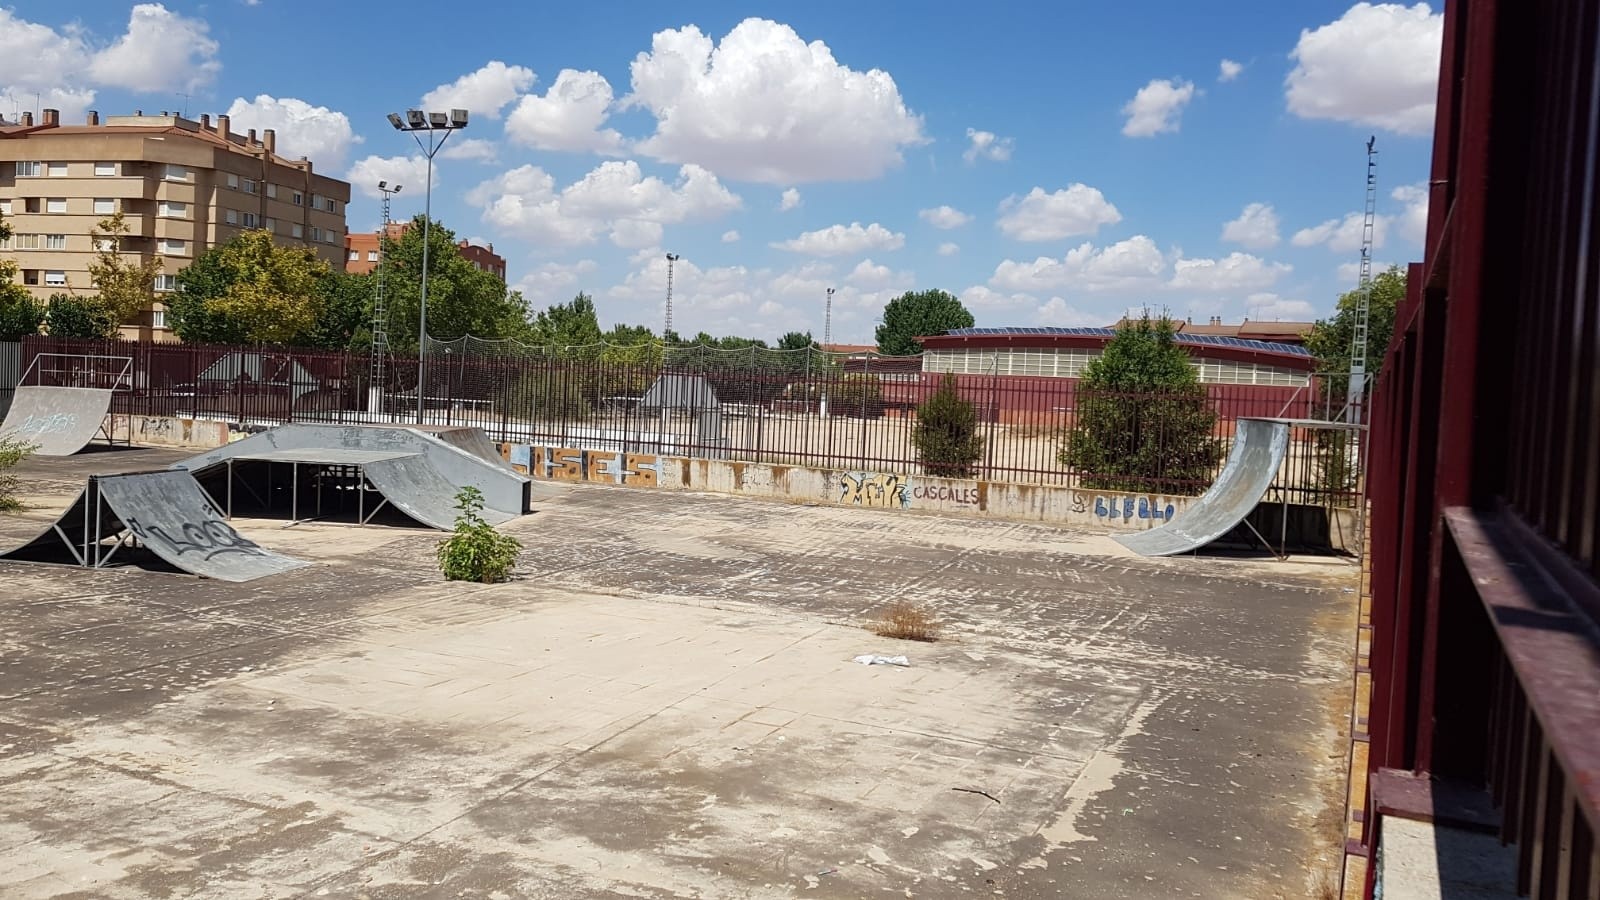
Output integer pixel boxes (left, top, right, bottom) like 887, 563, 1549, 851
624, 18, 925, 184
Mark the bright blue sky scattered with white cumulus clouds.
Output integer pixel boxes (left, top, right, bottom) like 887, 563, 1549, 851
0, 0, 1440, 343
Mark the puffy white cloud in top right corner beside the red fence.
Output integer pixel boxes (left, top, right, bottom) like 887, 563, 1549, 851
1285, 3, 1445, 135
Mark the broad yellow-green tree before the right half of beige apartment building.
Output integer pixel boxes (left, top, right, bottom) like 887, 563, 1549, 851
168, 231, 333, 344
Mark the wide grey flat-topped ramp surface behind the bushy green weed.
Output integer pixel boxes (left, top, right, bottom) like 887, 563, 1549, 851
174, 424, 534, 515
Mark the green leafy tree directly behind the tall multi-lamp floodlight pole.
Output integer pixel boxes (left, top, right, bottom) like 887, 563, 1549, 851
371, 216, 530, 351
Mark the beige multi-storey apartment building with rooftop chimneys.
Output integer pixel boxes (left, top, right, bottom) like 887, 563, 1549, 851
0, 109, 350, 340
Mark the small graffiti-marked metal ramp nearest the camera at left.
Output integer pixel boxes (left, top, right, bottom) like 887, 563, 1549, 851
0, 469, 310, 581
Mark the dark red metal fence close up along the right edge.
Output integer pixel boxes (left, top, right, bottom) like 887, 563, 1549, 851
1358, 0, 1600, 900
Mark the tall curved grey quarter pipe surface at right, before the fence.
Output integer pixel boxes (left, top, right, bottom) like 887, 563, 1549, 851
1117, 418, 1290, 556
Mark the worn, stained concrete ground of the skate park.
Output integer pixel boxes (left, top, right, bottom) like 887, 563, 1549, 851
0, 450, 1355, 898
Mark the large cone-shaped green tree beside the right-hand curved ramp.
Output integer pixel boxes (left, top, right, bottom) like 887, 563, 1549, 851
1059, 314, 1221, 493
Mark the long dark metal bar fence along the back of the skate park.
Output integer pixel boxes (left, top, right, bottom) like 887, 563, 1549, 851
24, 338, 1355, 506
